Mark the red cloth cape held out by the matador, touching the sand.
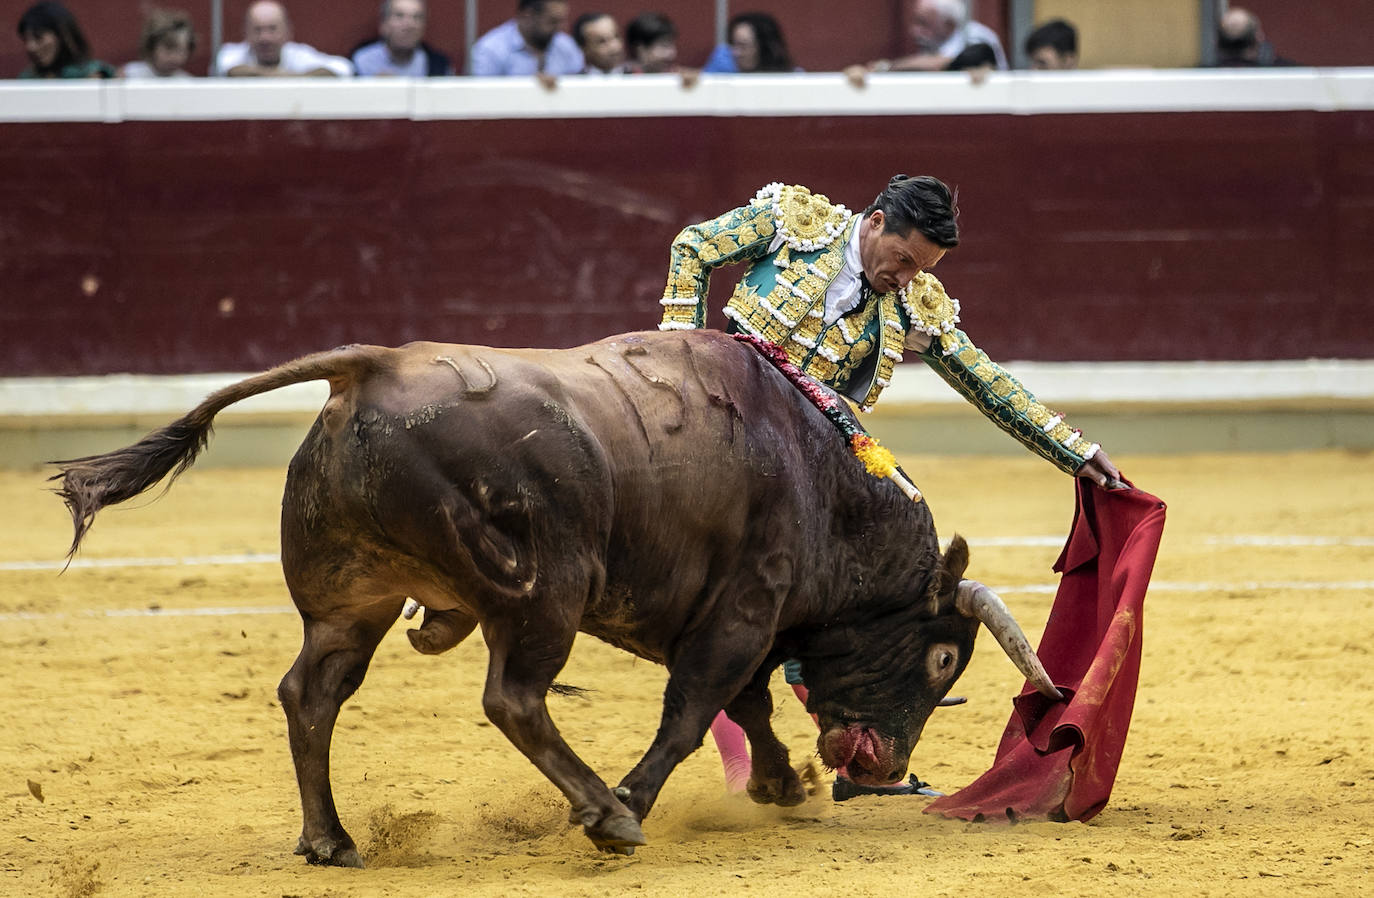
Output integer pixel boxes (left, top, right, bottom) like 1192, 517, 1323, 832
926, 478, 1164, 821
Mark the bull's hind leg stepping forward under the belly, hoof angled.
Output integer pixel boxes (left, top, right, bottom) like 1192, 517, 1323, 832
482, 604, 644, 854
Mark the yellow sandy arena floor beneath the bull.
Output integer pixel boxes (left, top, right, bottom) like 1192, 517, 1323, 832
0, 446, 1374, 898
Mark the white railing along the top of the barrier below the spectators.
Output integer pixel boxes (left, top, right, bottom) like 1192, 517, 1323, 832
0, 69, 1374, 122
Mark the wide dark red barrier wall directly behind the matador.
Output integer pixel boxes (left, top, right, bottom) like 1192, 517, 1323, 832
0, 111, 1374, 375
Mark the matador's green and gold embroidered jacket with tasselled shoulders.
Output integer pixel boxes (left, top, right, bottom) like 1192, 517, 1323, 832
658, 184, 1098, 474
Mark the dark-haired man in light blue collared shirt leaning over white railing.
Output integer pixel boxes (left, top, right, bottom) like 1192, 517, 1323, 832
469, 0, 584, 76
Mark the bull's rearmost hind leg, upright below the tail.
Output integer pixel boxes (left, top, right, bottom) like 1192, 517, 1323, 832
270, 597, 401, 866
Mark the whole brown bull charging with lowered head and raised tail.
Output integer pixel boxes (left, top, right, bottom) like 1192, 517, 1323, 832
54, 331, 1058, 866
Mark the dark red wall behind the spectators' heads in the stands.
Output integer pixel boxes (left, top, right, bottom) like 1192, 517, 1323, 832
0, 0, 1374, 78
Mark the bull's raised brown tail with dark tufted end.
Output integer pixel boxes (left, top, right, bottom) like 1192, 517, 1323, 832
48, 346, 389, 559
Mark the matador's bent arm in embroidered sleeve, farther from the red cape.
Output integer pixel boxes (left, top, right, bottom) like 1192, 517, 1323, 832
658, 199, 775, 331
